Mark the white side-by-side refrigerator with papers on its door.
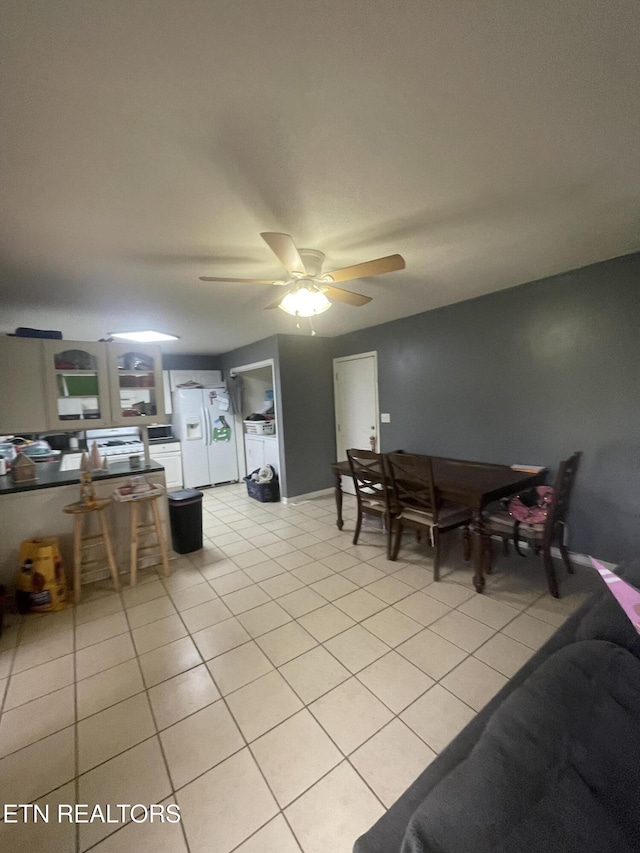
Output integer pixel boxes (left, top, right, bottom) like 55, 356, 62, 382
172, 385, 238, 488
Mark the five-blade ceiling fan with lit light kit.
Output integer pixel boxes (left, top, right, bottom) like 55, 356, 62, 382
200, 231, 405, 317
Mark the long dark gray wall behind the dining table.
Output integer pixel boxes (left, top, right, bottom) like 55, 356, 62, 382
332, 254, 640, 562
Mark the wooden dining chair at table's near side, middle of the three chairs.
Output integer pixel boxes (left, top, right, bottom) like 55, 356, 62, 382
387, 453, 471, 581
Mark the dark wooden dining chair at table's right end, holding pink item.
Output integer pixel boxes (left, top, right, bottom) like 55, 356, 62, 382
483, 452, 582, 598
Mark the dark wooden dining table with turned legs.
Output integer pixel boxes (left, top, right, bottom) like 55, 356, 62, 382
331, 456, 547, 592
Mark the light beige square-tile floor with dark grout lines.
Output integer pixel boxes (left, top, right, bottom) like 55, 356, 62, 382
0, 485, 597, 853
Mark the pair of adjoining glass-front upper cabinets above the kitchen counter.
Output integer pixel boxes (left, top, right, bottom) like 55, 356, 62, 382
40, 340, 164, 429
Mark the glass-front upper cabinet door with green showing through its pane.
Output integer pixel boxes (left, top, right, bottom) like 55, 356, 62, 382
43, 340, 111, 430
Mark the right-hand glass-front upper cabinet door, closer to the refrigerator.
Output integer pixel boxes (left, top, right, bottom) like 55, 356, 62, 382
106, 343, 165, 426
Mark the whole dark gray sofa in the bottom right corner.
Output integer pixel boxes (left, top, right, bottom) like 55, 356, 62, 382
354, 561, 640, 853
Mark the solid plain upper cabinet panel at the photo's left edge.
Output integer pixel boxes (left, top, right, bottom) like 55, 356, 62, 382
0, 336, 48, 435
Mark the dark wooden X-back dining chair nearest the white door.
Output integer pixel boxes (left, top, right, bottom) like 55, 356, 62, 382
347, 448, 395, 558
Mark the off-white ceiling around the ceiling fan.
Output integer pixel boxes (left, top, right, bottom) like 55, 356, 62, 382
0, 0, 640, 353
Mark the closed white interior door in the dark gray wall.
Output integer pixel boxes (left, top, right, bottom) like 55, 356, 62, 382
333, 352, 379, 493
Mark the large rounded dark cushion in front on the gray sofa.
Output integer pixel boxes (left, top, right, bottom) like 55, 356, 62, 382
402, 640, 640, 853
